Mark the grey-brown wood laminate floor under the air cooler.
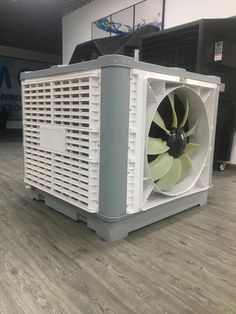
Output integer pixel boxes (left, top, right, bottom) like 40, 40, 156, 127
0, 133, 236, 314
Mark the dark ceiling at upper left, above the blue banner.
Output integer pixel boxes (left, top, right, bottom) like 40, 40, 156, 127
0, 0, 94, 55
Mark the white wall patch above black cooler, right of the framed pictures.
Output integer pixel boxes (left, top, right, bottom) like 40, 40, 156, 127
165, 0, 236, 28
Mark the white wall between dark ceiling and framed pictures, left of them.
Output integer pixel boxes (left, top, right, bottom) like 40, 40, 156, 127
62, 0, 140, 63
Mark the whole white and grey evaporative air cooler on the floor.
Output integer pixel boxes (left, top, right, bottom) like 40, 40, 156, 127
22, 55, 219, 240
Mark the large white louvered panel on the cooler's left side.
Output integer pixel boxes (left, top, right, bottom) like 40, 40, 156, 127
22, 70, 100, 212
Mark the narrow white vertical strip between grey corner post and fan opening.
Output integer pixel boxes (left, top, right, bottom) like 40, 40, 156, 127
127, 69, 146, 214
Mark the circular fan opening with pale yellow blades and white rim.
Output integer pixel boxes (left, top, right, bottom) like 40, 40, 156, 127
146, 87, 209, 196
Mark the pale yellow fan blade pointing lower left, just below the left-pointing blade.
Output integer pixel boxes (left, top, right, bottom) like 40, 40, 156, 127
149, 153, 174, 181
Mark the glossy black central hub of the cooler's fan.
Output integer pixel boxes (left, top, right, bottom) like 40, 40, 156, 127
167, 128, 187, 158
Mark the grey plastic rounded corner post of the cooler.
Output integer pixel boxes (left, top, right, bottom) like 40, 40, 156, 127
99, 66, 130, 218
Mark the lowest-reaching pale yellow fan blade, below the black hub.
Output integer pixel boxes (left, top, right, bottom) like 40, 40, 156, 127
156, 158, 181, 191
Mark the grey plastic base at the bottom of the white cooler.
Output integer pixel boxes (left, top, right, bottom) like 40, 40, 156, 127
28, 188, 208, 241
